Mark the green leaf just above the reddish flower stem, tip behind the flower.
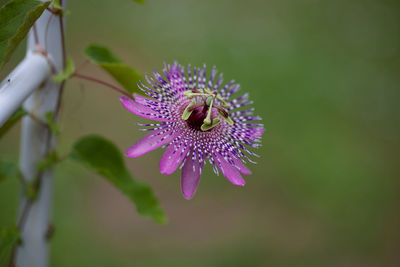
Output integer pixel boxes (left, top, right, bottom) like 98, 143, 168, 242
85, 44, 143, 93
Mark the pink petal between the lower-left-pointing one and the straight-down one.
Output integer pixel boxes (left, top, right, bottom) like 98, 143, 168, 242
159, 141, 190, 175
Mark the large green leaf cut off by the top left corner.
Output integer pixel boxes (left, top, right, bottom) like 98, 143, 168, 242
0, 0, 50, 70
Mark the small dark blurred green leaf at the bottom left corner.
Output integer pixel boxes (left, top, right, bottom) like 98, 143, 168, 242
0, 226, 21, 266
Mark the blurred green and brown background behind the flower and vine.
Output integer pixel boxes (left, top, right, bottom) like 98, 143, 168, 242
0, 0, 400, 267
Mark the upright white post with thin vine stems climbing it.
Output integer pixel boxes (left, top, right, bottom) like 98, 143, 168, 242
15, 0, 65, 267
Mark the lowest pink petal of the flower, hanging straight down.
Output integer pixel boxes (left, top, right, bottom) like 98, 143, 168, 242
181, 155, 200, 199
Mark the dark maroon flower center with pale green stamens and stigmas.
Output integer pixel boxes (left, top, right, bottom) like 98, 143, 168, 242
182, 89, 233, 132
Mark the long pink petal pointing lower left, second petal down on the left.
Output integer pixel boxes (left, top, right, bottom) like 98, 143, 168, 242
125, 129, 181, 158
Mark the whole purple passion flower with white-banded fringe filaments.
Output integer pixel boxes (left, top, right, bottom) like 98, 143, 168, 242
121, 62, 264, 199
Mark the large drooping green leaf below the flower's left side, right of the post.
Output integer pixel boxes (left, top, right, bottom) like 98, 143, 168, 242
70, 135, 166, 223
